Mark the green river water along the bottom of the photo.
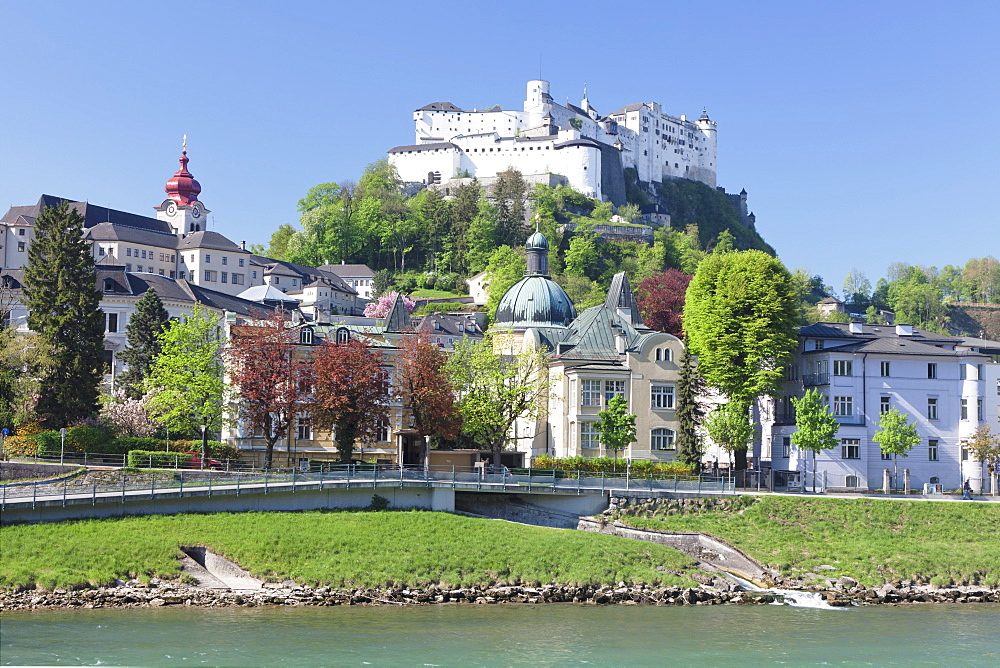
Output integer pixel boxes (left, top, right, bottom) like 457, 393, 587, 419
0, 604, 1000, 666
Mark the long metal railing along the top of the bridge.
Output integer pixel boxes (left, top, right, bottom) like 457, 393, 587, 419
0, 465, 735, 508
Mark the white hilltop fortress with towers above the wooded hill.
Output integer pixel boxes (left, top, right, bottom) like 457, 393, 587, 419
389, 79, 716, 205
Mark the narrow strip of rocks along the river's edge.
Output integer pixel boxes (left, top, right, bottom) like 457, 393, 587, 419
0, 579, 1000, 611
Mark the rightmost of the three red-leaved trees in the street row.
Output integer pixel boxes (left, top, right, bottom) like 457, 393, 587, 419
397, 335, 462, 463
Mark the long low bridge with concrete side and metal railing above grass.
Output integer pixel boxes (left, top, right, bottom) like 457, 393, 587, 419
0, 466, 735, 524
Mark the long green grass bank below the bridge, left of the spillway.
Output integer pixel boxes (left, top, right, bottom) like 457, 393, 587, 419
0, 511, 697, 589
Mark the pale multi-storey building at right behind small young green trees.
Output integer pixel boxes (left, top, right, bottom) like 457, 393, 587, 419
755, 322, 1000, 490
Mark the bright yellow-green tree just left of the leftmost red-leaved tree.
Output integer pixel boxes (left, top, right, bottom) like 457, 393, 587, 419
146, 304, 229, 461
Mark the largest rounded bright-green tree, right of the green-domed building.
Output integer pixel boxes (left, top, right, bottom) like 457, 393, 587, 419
684, 250, 798, 469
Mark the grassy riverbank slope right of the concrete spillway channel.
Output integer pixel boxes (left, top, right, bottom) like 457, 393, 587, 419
620, 497, 1000, 587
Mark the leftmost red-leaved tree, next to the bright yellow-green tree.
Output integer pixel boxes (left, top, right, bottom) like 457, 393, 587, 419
226, 314, 312, 468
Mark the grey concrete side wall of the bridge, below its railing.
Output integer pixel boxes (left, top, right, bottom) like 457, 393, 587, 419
3, 487, 455, 524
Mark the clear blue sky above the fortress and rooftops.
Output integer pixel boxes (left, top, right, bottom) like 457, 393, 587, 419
0, 0, 1000, 289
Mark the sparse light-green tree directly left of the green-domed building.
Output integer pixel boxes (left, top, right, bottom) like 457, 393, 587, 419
446, 333, 549, 466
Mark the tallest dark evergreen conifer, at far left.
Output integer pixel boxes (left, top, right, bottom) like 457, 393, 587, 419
24, 201, 104, 428
